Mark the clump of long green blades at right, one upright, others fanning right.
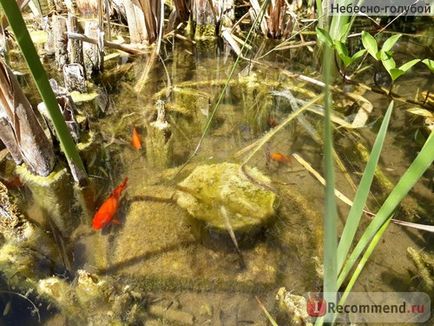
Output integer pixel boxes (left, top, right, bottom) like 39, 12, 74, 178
316, 39, 434, 325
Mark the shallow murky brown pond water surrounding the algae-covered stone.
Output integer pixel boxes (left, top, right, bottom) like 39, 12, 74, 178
0, 35, 434, 325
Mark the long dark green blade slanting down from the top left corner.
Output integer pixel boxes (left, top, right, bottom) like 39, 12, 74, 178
0, 0, 86, 175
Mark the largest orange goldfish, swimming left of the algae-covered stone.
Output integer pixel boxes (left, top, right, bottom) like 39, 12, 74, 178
92, 178, 128, 230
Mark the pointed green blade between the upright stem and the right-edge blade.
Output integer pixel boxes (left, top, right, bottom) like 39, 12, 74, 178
338, 101, 393, 270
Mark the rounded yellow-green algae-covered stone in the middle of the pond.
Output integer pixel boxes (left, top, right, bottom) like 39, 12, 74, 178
177, 163, 276, 232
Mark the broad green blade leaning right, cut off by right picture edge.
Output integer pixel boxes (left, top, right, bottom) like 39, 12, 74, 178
338, 131, 434, 286
